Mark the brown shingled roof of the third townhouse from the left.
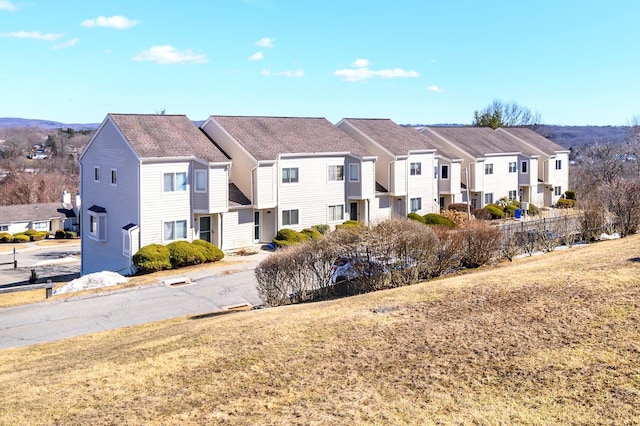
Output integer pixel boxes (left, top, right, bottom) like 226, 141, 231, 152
342, 118, 436, 155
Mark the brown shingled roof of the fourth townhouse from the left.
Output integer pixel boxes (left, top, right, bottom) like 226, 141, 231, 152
428, 126, 536, 158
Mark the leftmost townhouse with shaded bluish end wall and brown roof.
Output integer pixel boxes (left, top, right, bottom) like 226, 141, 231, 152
79, 114, 230, 274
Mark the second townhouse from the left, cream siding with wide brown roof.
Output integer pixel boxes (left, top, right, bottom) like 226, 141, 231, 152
202, 116, 376, 243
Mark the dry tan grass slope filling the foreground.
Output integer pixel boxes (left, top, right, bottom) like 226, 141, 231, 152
0, 236, 640, 425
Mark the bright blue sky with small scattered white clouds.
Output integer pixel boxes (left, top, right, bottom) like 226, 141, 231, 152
0, 0, 640, 125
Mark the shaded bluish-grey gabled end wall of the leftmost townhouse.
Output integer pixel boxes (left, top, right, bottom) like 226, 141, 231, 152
80, 121, 140, 274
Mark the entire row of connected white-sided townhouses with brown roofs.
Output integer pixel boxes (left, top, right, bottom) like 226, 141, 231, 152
79, 114, 569, 274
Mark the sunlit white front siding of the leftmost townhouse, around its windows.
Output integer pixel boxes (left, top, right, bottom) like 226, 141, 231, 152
140, 162, 194, 246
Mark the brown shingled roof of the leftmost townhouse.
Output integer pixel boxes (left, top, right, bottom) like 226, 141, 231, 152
109, 114, 229, 163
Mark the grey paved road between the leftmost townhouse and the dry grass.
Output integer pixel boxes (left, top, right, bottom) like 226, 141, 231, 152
0, 246, 268, 349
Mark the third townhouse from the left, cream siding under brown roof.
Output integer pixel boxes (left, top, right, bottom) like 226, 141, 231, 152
336, 118, 440, 216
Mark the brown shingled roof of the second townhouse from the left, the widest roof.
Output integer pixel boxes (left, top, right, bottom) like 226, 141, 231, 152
211, 116, 370, 161
